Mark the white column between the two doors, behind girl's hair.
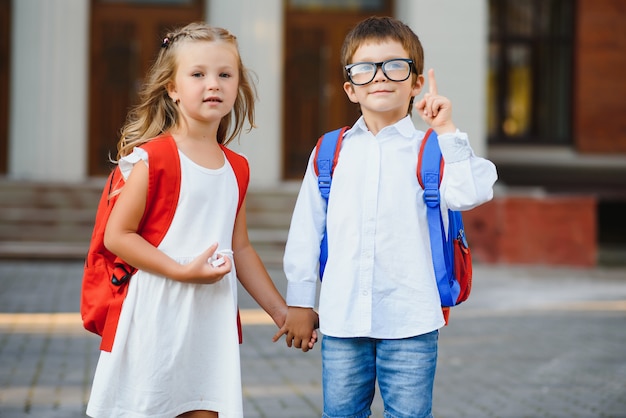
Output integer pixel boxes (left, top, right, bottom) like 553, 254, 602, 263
207, 0, 283, 188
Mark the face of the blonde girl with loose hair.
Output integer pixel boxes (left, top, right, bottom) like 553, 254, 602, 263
168, 41, 239, 129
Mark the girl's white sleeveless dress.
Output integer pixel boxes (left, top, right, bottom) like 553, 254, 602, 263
87, 148, 243, 418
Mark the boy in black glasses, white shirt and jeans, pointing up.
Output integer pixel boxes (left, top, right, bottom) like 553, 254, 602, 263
284, 17, 497, 418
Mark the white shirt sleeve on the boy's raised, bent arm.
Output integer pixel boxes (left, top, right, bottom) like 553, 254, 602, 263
439, 130, 498, 210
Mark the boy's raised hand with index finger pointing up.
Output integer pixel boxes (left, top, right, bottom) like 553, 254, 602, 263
415, 68, 456, 135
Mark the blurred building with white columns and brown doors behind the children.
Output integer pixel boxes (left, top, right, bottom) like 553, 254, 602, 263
0, 0, 626, 265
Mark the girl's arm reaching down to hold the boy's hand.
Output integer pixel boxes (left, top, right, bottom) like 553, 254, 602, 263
233, 201, 317, 351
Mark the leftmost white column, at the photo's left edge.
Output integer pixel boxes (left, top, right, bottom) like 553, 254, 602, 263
8, 0, 89, 182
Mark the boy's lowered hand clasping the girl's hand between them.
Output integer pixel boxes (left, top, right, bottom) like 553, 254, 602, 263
272, 306, 319, 353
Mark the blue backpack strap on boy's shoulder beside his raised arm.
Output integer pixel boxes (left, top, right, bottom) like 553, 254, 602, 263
418, 129, 460, 306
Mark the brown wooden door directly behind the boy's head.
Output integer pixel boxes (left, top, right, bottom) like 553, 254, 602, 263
283, 0, 392, 180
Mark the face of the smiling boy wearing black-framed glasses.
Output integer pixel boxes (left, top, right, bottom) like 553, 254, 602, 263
343, 39, 424, 123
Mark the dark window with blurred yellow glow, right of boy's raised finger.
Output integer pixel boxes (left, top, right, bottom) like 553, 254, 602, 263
487, 0, 575, 145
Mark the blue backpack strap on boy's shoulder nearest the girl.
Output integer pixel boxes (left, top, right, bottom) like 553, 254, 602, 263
313, 126, 349, 280
